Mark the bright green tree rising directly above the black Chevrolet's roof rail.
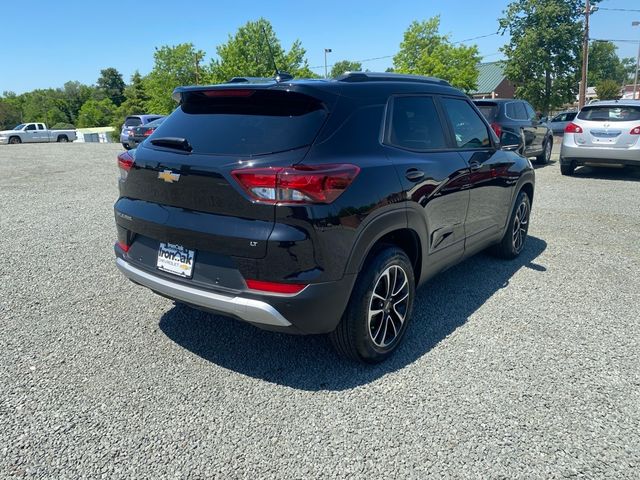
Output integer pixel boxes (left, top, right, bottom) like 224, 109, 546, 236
393, 16, 480, 92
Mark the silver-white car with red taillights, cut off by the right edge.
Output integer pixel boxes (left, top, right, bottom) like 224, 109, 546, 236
560, 100, 640, 175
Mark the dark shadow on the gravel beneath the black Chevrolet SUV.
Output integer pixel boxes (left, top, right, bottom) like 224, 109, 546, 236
160, 237, 547, 391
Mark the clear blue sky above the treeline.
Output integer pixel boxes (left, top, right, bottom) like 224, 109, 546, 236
0, 0, 640, 93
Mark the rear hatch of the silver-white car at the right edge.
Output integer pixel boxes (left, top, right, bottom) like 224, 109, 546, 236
574, 104, 640, 148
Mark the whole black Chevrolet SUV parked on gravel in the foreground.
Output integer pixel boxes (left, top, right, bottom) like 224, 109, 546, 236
115, 73, 534, 363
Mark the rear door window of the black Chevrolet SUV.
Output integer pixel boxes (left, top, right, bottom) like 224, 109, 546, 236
387, 96, 447, 151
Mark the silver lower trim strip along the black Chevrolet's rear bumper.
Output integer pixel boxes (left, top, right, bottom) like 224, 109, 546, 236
116, 258, 291, 327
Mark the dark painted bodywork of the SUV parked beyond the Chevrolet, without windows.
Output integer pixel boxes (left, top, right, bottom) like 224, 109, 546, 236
474, 98, 553, 157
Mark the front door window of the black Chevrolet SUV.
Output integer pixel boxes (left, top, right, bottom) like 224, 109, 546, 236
442, 98, 491, 148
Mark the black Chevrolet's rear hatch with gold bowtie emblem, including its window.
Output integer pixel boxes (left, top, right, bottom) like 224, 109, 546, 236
116, 86, 329, 258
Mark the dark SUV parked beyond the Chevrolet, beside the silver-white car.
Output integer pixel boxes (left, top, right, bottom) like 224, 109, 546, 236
474, 98, 553, 164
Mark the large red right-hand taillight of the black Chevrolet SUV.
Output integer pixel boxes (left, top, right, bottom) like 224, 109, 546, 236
231, 164, 360, 203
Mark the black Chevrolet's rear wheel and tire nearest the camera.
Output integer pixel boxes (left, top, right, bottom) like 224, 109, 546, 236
329, 246, 415, 364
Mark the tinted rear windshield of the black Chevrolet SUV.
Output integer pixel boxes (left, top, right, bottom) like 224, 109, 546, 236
154, 89, 328, 155
